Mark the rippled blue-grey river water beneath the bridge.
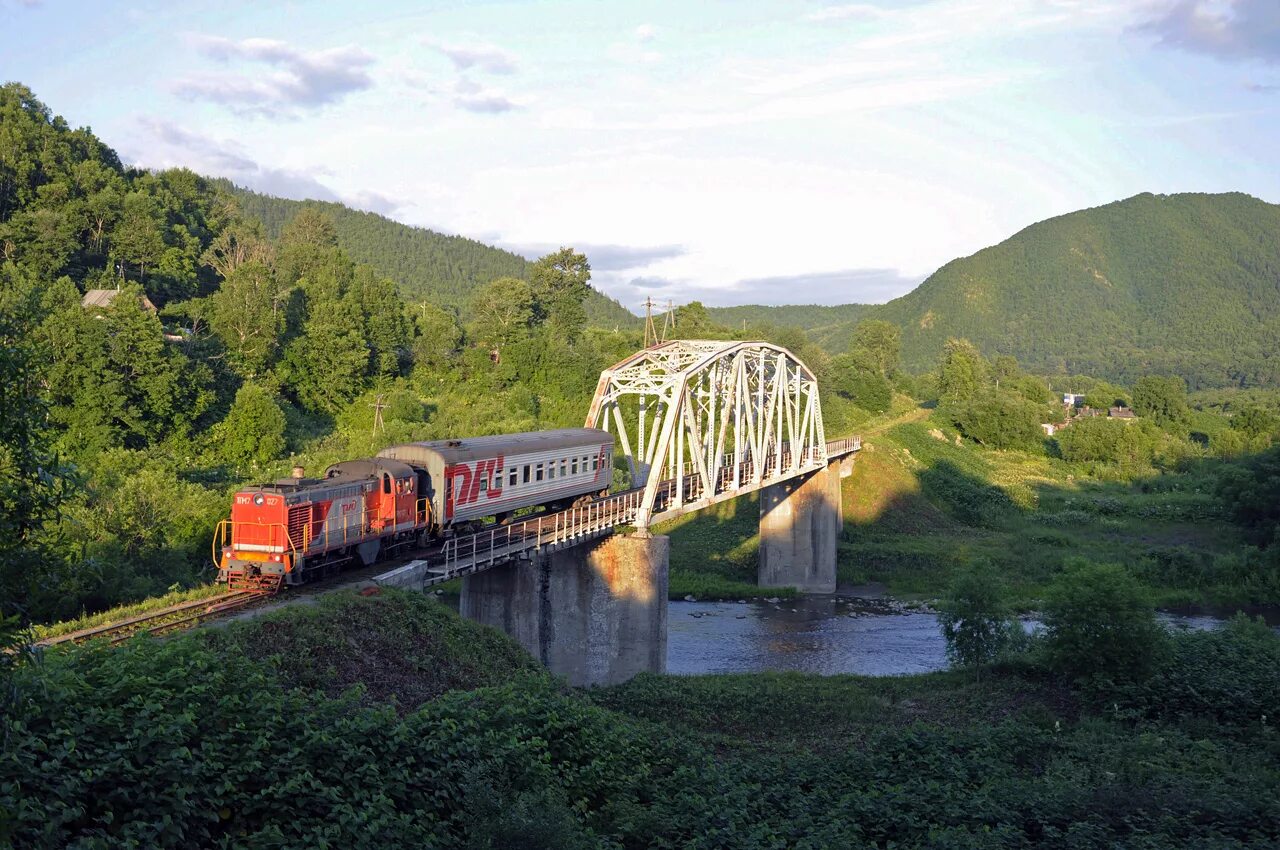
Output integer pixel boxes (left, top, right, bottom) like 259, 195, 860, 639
667, 597, 1280, 676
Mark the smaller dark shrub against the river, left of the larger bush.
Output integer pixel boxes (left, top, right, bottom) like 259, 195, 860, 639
938, 563, 1021, 667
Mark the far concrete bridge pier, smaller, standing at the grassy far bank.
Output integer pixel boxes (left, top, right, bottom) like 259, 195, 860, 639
758, 460, 847, 593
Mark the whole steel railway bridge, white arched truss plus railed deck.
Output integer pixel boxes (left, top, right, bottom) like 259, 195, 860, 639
375, 339, 861, 588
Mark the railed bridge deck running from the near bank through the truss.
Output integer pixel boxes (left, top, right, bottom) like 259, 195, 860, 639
372, 437, 861, 589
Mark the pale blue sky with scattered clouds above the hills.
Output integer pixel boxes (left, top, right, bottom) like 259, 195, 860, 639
0, 0, 1280, 310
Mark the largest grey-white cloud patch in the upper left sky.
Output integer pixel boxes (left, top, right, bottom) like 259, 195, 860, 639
172, 35, 374, 114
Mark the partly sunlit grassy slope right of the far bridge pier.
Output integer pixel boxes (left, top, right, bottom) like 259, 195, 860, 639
838, 422, 1266, 608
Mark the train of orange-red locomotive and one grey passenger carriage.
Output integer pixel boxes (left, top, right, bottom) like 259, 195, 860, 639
214, 428, 613, 589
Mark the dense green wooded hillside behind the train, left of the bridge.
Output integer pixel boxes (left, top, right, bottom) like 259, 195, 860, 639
0, 83, 680, 621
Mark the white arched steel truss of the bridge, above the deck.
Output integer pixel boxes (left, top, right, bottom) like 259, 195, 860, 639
586, 339, 827, 530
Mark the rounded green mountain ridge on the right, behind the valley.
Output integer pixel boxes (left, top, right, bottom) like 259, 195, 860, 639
712, 193, 1280, 385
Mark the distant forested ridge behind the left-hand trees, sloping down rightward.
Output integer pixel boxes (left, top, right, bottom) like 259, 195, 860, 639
225, 180, 640, 328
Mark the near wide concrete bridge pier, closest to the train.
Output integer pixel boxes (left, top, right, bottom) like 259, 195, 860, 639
460, 535, 669, 686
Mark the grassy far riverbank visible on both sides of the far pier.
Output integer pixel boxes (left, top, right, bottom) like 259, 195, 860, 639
658, 417, 1280, 611
